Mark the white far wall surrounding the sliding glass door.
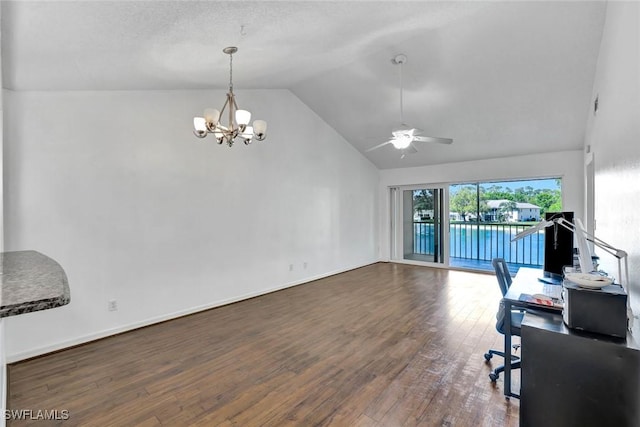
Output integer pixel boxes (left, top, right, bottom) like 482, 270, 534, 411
380, 150, 584, 260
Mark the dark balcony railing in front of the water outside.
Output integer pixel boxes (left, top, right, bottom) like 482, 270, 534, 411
413, 221, 544, 266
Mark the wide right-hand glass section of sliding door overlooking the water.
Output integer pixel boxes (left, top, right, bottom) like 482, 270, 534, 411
449, 178, 562, 270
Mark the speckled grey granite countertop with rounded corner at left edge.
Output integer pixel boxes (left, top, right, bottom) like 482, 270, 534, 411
0, 251, 71, 317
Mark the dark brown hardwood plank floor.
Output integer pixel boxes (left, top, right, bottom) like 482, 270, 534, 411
8, 263, 519, 427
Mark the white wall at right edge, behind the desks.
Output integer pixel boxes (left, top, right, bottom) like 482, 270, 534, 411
586, 1, 640, 324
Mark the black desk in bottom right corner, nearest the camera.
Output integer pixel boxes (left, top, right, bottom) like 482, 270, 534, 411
520, 313, 640, 427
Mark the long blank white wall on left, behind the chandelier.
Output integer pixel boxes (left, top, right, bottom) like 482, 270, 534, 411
4, 90, 379, 361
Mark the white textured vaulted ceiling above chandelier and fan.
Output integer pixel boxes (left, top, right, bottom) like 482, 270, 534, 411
1, 1, 605, 168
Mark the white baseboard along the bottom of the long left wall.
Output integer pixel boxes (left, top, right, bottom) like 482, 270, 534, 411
6, 261, 378, 363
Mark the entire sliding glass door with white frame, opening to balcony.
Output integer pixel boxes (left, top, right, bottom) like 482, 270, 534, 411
390, 178, 562, 270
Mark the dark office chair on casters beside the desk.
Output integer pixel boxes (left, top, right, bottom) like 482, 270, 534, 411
484, 258, 524, 382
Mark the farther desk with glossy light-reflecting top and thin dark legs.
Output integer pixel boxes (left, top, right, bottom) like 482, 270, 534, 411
503, 267, 560, 398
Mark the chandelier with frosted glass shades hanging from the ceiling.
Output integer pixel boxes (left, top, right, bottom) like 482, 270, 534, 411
193, 46, 267, 147
